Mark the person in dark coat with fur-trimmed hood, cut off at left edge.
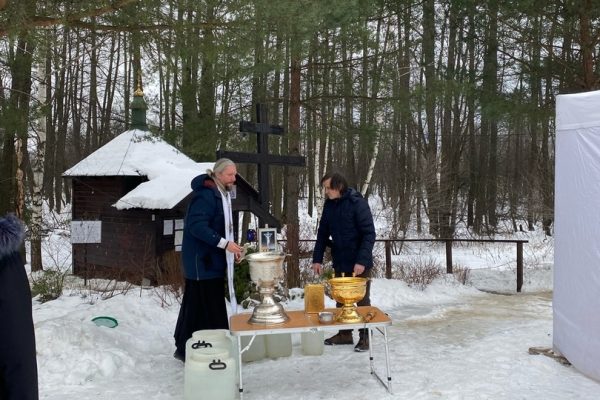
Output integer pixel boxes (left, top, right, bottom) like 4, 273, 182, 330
0, 214, 38, 400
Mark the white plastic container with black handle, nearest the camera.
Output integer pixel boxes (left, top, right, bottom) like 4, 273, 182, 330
183, 347, 237, 400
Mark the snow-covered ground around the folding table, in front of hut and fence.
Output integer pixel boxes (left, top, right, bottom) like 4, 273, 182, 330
34, 236, 600, 400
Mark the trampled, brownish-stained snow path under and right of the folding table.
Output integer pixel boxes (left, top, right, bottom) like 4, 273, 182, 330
239, 292, 600, 400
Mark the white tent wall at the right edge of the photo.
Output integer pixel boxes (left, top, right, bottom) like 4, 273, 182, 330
553, 91, 600, 380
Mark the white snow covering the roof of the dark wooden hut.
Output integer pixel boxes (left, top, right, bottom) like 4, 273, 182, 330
63, 129, 214, 210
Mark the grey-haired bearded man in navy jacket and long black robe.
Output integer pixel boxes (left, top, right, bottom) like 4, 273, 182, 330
174, 158, 242, 361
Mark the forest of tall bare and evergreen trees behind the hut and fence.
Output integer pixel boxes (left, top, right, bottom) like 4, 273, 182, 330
0, 0, 600, 266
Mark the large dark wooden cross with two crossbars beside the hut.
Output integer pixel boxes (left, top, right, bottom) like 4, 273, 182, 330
217, 104, 306, 225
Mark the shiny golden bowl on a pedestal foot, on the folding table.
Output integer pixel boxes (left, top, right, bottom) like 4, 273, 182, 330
329, 277, 367, 323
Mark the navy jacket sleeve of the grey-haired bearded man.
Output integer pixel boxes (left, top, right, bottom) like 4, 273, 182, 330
186, 190, 221, 246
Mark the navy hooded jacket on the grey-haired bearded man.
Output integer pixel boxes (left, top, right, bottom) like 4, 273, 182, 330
182, 174, 227, 280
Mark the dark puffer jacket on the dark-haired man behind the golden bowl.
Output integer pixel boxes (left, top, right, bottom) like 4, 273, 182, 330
313, 188, 375, 274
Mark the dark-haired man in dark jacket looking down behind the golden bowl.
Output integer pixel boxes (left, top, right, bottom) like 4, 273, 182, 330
313, 172, 375, 351
